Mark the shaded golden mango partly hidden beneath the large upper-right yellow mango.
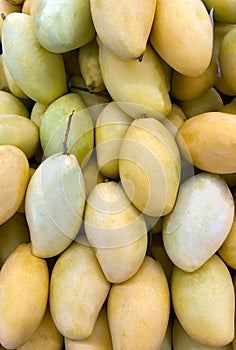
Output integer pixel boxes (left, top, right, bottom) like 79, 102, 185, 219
171, 58, 217, 101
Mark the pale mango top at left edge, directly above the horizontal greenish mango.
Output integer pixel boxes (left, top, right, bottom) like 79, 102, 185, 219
0, 91, 29, 118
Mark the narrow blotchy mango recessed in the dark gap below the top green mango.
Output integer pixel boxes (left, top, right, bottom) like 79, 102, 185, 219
78, 39, 105, 92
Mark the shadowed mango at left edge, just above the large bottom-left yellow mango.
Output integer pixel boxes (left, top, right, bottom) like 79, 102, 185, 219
0, 213, 29, 263
